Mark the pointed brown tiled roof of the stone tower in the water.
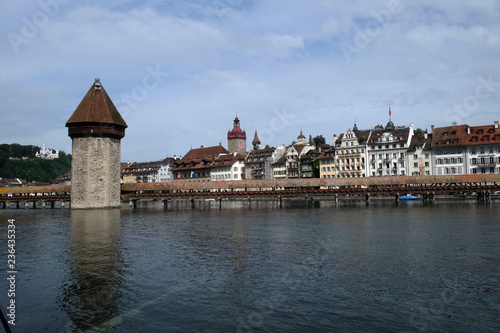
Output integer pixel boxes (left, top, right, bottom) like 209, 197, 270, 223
66, 79, 128, 138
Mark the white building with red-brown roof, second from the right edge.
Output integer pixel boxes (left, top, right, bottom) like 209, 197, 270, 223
431, 122, 469, 175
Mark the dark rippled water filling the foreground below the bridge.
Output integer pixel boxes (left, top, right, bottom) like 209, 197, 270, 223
0, 202, 500, 332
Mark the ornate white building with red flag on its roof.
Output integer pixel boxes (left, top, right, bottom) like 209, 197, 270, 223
367, 120, 413, 176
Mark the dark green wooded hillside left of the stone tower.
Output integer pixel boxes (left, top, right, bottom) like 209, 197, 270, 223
0, 143, 71, 183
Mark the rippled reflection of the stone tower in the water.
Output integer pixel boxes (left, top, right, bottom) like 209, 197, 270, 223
62, 209, 124, 332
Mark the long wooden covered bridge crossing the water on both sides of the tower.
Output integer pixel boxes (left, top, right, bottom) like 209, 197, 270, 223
0, 174, 500, 208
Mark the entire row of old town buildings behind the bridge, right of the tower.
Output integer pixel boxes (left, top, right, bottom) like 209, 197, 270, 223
118, 113, 500, 183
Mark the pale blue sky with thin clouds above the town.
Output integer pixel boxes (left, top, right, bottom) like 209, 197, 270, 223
0, 0, 500, 162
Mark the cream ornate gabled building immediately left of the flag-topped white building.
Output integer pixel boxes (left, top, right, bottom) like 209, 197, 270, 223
335, 123, 372, 178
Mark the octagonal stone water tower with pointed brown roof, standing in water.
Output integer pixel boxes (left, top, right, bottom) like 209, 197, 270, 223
66, 79, 127, 209
